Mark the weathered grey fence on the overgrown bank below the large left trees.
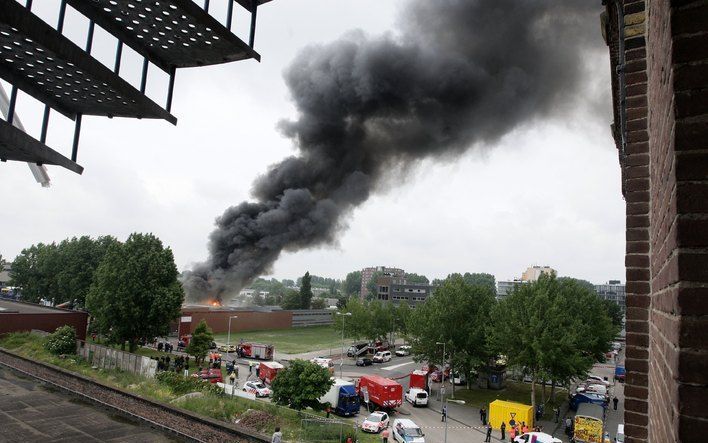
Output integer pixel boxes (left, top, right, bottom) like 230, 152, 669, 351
76, 340, 157, 377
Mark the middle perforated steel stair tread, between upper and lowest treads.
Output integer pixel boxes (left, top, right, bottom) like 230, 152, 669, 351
0, 0, 177, 124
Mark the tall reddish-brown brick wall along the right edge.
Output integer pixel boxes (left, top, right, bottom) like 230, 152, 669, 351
606, 0, 708, 443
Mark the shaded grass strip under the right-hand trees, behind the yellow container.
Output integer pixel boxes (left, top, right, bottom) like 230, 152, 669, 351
447, 380, 567, 420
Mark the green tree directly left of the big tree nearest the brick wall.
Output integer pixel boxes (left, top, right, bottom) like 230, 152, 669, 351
407, 276, 494, 392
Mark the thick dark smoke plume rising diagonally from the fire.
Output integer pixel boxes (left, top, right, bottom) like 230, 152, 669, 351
184, 0, 601, 300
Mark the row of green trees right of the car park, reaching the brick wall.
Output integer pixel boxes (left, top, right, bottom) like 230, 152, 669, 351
335, 274, 622, 416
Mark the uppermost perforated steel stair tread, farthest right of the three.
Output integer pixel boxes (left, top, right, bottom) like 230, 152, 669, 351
68, 0, 260, 72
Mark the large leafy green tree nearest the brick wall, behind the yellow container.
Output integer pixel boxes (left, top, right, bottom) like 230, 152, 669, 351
489, 275, 617, 416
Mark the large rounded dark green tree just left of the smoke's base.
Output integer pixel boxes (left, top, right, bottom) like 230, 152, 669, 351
86, 233, 184, 351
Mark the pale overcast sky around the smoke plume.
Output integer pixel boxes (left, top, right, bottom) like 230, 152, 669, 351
0, 0, 624, 283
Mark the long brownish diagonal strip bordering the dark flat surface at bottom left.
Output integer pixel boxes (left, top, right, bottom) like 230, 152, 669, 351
0, 349, 270, 443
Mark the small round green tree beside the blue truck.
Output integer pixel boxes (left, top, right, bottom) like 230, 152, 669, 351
271, 360, 333, 410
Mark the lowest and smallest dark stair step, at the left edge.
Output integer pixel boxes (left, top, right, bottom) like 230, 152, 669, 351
0, 120, 84, 174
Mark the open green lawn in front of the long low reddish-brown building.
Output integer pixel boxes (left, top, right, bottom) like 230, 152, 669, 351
214, 326, 344, 354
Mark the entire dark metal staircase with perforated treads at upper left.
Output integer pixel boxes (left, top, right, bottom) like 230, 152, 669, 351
0, 0, 270, 174
